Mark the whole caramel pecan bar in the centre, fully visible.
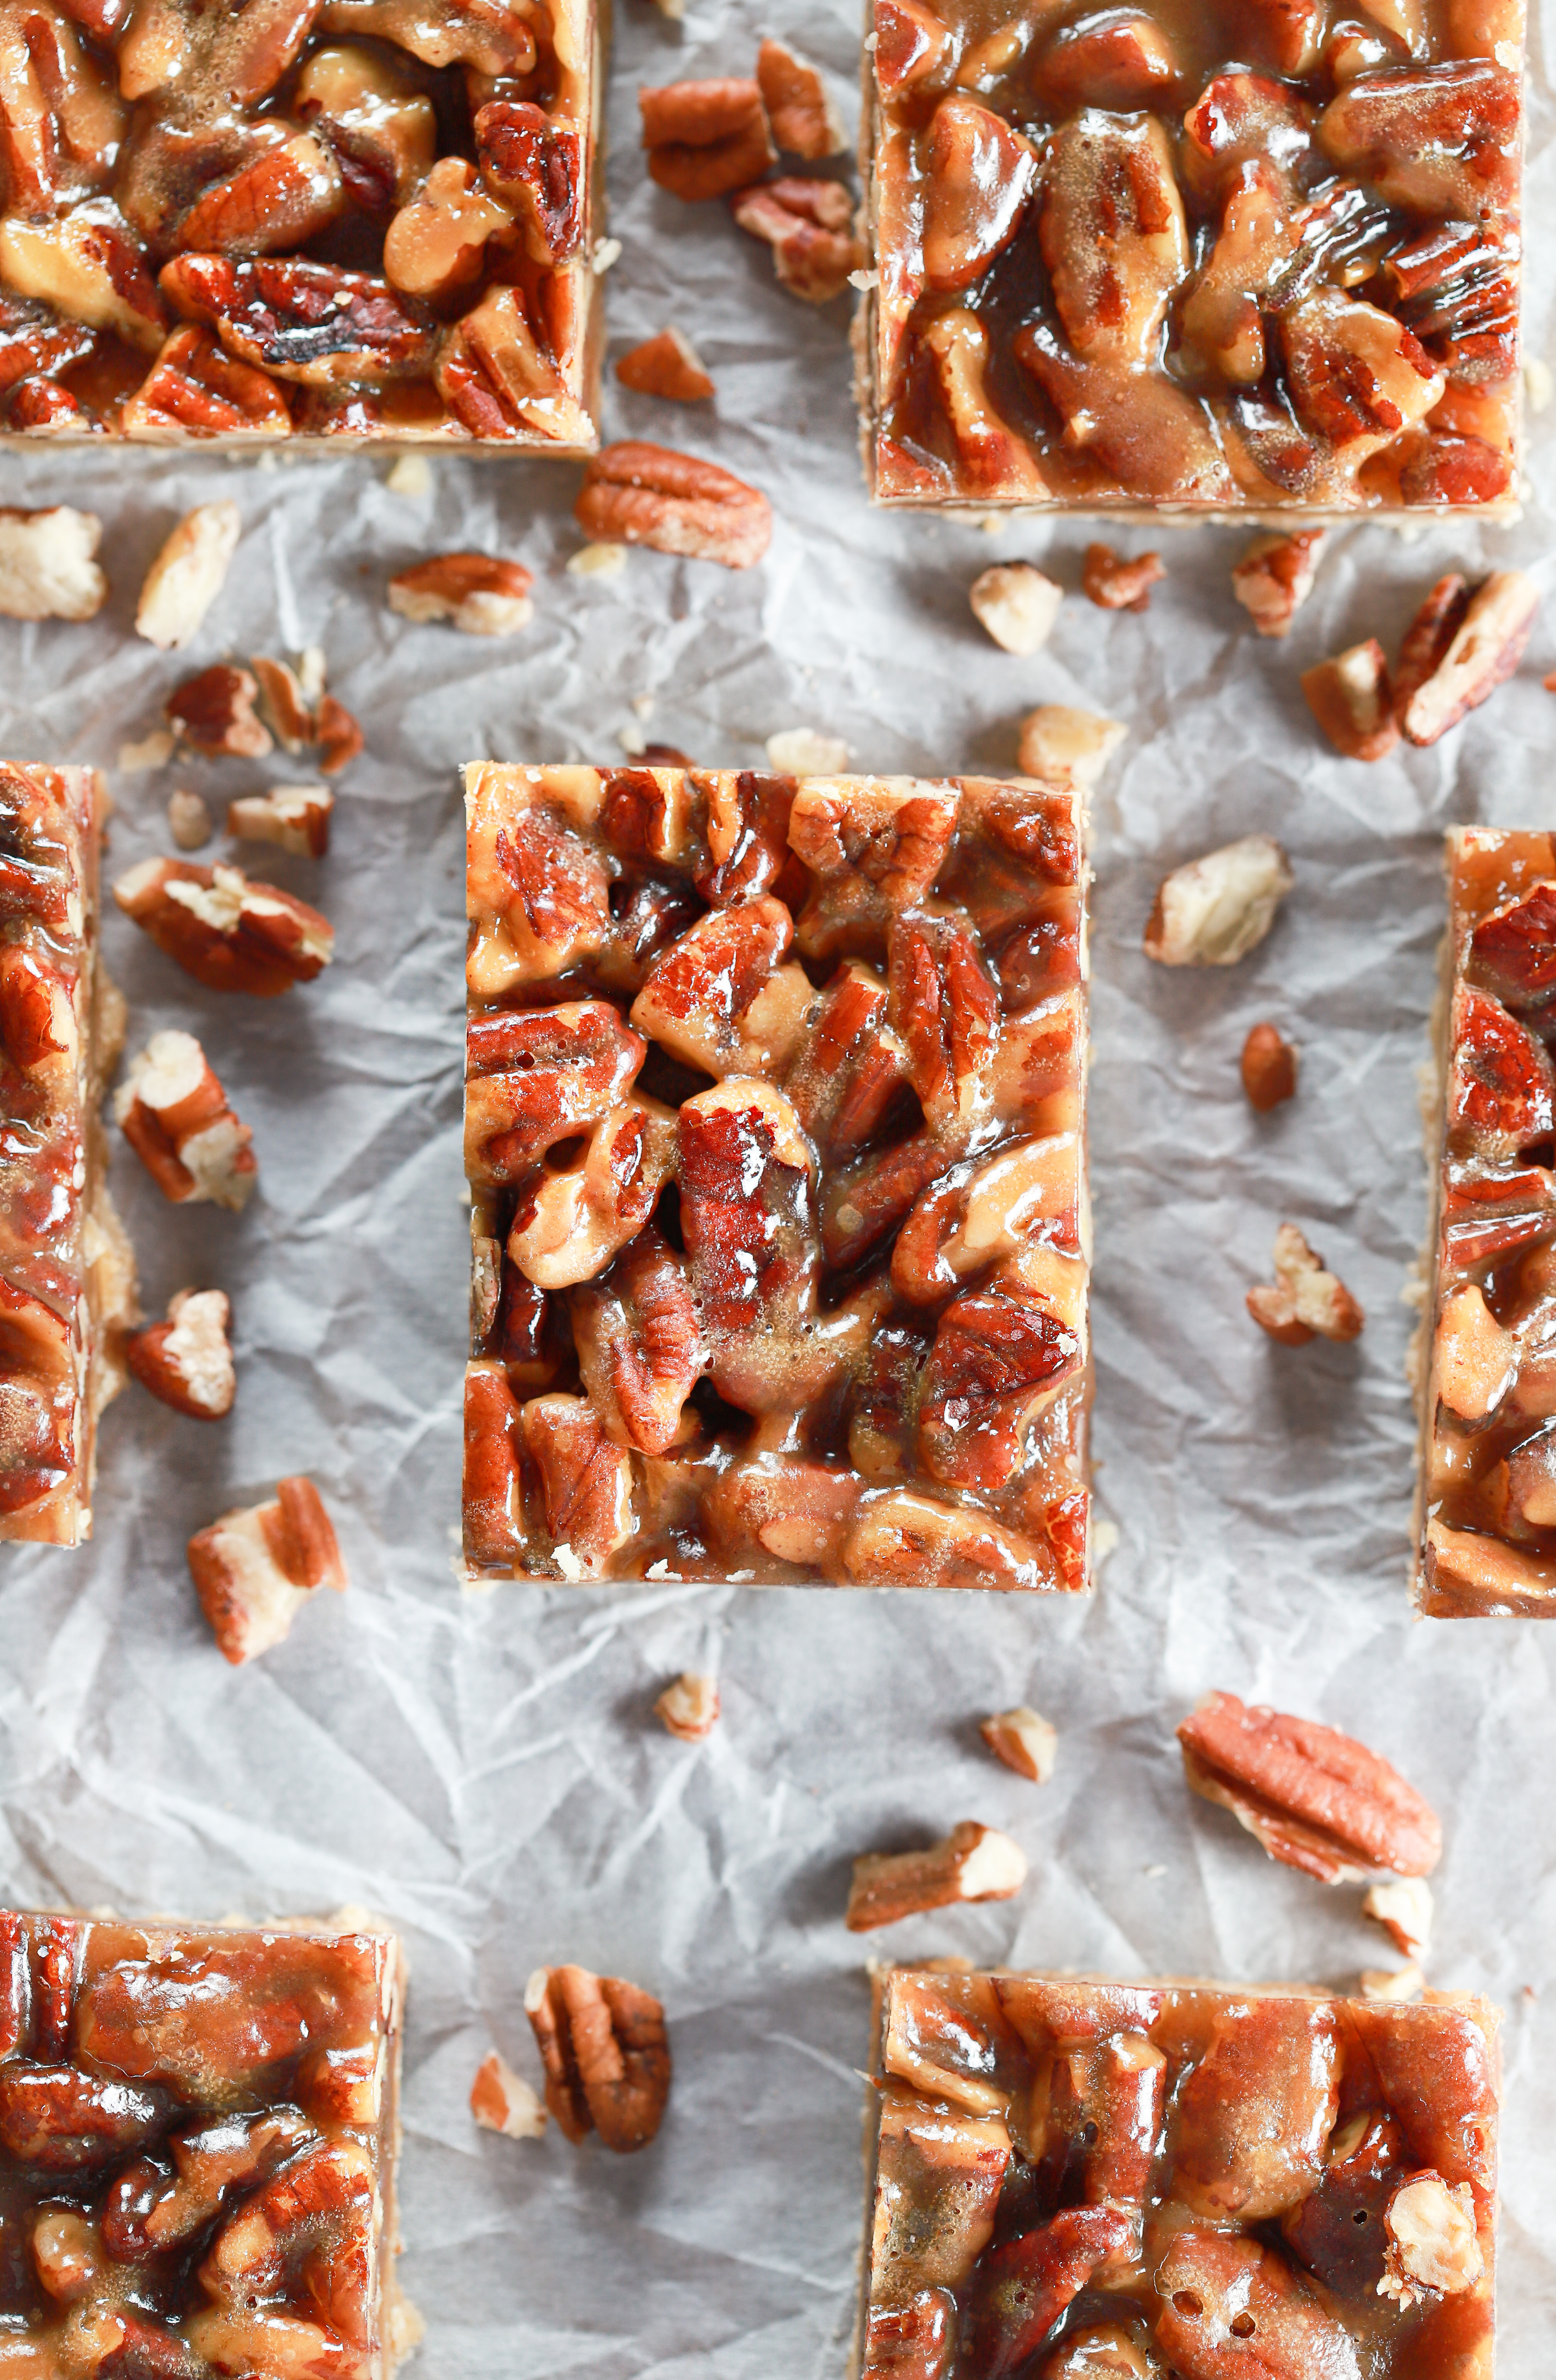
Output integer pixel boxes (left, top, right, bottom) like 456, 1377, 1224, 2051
464, 764, 1090, 1590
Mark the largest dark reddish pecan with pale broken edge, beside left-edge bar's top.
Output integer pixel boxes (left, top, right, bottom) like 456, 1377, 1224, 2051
114, 859, 335, 1000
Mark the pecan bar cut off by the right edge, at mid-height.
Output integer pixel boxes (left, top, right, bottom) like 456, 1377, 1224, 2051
1416, 826, 1556, 1618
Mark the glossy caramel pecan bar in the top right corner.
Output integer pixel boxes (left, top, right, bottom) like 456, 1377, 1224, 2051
859, 0, 1523, 519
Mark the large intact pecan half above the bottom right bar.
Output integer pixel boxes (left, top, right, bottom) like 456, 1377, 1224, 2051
1178, 1694, 1442, 1885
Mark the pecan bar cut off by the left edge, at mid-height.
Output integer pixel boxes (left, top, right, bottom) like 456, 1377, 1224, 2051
0, 762, 136, 1545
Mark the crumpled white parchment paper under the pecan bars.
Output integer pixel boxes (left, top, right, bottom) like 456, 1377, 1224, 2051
0, 0, 1556, 2380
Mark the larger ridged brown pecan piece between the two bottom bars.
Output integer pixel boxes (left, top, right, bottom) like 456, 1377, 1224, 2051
524, 1966, 671, 2156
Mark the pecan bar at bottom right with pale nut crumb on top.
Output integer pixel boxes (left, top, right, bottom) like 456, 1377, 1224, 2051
861, 1968, 1499, 2380
